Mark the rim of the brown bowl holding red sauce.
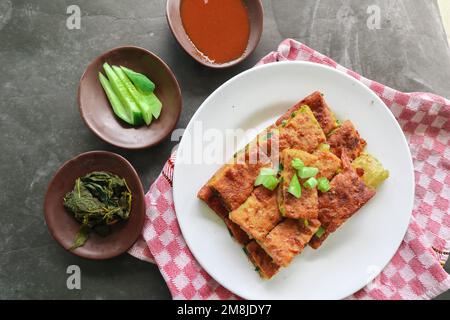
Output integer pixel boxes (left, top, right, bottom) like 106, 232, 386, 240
166, 0, 264, 69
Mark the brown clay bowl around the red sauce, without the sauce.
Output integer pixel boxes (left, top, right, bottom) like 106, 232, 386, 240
166, 0, 264, 69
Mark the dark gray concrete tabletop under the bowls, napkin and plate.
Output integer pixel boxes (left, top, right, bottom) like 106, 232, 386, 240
0, 0, 450, 299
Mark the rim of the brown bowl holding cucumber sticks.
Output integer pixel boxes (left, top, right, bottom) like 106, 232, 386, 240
77, 45, 183, 150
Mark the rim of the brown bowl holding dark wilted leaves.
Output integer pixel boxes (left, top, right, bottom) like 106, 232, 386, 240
43, 150, 145, 260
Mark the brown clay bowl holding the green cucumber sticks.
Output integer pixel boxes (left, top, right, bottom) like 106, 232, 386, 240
78, 46, 182, 149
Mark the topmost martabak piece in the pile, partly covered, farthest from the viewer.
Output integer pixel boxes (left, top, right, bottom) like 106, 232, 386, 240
277, 91, 337, 134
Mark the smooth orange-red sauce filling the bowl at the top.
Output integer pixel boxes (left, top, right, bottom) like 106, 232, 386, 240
180, 0, 250, 63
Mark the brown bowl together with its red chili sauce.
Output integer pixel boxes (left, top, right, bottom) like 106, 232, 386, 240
166, 0, 264, 68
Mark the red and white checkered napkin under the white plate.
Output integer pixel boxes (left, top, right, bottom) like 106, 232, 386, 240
130, 39, 450, 300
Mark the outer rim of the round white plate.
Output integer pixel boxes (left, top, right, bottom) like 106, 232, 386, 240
173, 61, 415, 300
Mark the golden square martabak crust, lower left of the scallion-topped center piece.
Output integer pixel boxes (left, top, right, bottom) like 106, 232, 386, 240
230, 187, 281, 240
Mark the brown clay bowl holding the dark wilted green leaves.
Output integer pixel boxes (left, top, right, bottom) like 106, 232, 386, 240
44, 151, 145, 260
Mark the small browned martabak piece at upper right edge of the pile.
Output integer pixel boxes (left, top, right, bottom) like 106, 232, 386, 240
328, 120, 367, 161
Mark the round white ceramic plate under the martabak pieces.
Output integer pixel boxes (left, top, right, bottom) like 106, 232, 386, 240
174, 62, 414, 299
